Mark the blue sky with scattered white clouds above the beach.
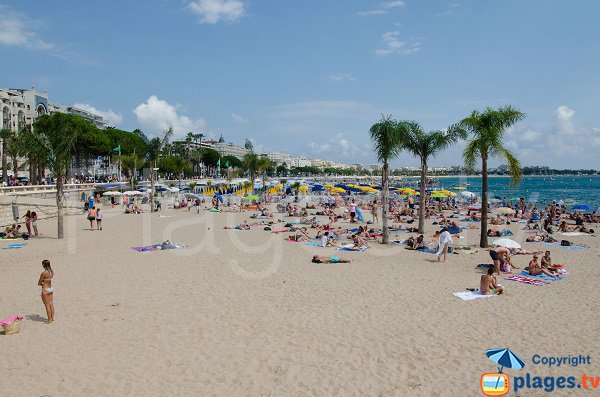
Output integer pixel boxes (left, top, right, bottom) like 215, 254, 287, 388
0, 0, 600, 168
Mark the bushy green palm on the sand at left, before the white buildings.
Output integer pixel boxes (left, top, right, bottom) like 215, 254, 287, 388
30, 113, 88, 239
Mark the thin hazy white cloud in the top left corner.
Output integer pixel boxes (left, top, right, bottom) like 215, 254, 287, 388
0, 5, 55, 50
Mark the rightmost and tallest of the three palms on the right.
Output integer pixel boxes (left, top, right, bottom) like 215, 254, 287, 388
459, 105, 525, 248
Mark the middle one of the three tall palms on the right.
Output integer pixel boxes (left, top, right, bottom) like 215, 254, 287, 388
398, 121, 467, 234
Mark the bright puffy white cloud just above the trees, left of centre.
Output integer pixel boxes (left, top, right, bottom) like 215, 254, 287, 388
133, 95, 206, 136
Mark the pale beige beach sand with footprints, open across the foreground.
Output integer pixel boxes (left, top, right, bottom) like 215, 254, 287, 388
0, 203, 600, 396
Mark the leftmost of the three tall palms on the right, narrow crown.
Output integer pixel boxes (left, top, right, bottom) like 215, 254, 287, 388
369, 116, 401, 244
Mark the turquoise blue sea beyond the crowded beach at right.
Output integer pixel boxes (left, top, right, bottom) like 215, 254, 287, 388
437, 176, 600, 208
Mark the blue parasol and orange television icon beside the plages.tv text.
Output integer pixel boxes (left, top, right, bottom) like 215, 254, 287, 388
480, 348, 525, 396
